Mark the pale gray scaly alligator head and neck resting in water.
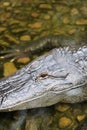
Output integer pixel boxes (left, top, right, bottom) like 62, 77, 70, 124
0, 47, 87, 111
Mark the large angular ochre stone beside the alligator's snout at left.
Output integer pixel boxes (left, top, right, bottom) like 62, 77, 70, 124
3, 62, 17, 77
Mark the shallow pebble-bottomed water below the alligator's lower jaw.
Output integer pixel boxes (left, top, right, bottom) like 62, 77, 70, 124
0, 103, 87, 130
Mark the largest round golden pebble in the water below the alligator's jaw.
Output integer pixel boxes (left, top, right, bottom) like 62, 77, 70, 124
59, 117, 72, 129
